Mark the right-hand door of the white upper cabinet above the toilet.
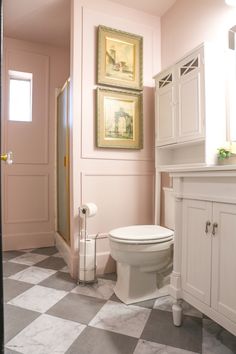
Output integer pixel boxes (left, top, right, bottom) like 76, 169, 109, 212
177, 53, 204, 142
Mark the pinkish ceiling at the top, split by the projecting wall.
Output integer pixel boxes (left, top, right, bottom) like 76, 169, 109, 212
3, 0, 176, 47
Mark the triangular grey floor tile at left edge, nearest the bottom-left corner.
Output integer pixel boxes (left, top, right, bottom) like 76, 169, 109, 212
4, 304, 40, 343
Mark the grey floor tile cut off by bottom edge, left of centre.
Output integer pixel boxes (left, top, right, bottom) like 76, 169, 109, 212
66, 327, 137, 354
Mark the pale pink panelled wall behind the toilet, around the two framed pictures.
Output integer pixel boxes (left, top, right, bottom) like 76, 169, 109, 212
71, 0, 160, 275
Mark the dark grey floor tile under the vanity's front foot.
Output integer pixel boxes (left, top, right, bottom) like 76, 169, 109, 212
141, 310, 202, 353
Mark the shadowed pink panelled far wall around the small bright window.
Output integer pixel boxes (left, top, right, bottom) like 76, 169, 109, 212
2, 38, 70, 249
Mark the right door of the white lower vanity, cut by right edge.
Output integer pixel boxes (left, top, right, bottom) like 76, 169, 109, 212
212, 203, 236, 322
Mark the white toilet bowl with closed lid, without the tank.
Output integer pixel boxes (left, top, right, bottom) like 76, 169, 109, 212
109, 225, 174, 304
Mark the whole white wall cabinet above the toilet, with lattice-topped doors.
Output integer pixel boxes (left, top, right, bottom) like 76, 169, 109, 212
155, 43, 230, 167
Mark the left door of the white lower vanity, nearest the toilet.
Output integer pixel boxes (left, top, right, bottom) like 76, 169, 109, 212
182, 200, 212, 305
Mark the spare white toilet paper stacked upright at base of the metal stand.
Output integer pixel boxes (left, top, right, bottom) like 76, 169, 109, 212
79, 239, 96, 281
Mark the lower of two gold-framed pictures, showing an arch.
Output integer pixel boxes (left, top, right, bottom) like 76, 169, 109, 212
97, 88, 143, 149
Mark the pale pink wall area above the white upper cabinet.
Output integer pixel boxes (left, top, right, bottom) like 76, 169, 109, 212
161, 0, 236, 69
